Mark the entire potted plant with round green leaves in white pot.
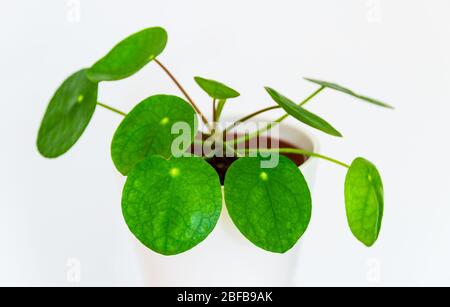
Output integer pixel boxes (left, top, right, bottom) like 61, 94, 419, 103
37, 28, 391, 285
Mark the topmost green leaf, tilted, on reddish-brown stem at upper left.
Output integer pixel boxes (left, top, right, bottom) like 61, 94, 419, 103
88, 28, 167, 82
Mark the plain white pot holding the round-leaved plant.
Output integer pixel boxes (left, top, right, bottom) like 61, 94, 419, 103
136, 124, 318, 287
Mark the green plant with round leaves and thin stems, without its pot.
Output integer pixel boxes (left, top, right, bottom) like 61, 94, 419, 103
37, 28, 391, 255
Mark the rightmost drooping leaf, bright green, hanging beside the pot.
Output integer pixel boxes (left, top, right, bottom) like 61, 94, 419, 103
345, 158, 384, 247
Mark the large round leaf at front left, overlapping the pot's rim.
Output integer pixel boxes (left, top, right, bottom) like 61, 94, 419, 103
122, 156, 222, 255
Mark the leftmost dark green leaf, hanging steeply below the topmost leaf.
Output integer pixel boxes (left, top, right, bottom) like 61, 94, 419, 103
37, 70, 98, 158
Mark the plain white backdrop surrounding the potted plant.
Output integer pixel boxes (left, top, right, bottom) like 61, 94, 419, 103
0, 0, 450, 286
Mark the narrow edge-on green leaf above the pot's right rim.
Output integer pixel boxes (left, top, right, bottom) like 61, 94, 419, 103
266, 87, 342, 137
